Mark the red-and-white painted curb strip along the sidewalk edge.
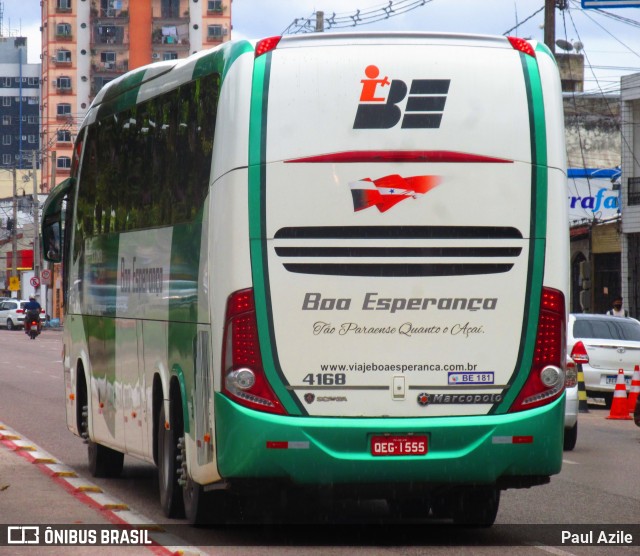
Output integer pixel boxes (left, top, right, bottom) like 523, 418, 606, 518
0, 422, 207, 556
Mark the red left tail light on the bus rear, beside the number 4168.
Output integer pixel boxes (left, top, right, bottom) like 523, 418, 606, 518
222, 289, 286, 415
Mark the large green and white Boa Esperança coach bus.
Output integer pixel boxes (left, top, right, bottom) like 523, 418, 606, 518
43, 33, 569, 525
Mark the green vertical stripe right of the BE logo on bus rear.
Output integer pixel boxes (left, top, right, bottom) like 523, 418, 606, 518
491, 54, 548, 413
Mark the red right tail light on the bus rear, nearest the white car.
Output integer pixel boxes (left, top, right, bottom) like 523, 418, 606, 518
509, 288, 566, 413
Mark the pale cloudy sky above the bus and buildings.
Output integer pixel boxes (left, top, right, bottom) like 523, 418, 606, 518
5, 0, 640, 92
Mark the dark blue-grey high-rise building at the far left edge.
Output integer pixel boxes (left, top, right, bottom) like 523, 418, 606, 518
0, 36, 40, 174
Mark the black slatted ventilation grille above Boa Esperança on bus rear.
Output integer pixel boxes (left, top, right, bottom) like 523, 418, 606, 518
274, 226, 523, 277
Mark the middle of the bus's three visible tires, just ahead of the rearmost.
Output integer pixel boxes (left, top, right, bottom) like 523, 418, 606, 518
158, 402, 184, 518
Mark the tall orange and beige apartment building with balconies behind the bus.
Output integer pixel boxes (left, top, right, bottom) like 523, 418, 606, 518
41, 0, 231, 191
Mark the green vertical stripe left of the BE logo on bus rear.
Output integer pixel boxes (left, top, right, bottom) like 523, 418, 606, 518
248, 53, 306, 415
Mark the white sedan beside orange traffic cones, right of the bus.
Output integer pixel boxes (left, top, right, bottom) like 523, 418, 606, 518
567, 313, 640, 408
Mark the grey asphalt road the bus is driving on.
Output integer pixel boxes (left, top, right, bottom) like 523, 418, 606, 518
0, 330, 640, 555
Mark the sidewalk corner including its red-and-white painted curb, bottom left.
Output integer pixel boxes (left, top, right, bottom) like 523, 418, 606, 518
0, 423, 202, 556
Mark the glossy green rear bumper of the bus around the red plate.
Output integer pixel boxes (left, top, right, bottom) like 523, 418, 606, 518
215, 394, 564, 489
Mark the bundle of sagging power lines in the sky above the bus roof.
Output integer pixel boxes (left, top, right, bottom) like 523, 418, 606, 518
282, 0, 433, 35
